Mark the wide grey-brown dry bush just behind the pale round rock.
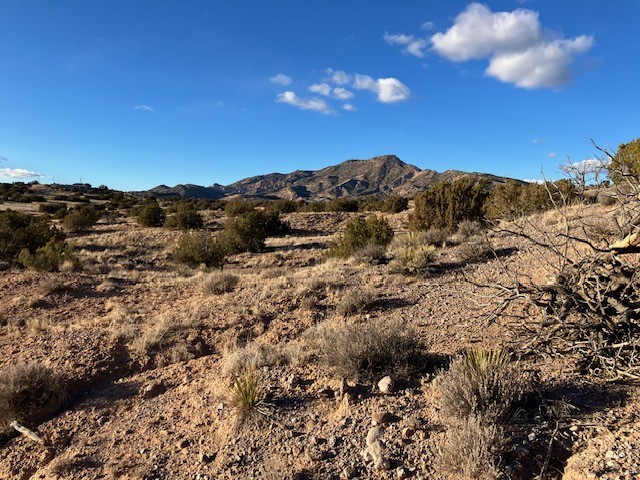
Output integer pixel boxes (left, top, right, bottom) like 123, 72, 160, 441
307, 319, 421, 380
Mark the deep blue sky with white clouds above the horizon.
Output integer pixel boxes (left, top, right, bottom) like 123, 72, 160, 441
0, 0, 640, 190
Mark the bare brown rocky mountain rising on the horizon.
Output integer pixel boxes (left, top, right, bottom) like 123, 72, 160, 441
137, 155, 524, 200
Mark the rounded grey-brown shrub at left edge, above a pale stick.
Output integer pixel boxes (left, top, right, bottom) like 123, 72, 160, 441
0, 363, 66, 428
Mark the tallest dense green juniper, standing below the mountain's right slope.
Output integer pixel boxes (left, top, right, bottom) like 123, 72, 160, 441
409, 177, 489, 231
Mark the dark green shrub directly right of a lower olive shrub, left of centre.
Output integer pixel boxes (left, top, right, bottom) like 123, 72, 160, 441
220, 210, 289, 253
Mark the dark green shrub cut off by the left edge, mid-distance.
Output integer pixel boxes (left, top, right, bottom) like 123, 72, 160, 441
0, 210, 64, 262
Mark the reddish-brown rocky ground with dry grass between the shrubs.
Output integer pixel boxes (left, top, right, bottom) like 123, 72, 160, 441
0, 207, 640, 480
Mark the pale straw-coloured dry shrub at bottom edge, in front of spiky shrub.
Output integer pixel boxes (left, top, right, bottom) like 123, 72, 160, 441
440, 416, 505, 480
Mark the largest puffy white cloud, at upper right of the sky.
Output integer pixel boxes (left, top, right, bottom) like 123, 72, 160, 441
431, 3, 594, 89
